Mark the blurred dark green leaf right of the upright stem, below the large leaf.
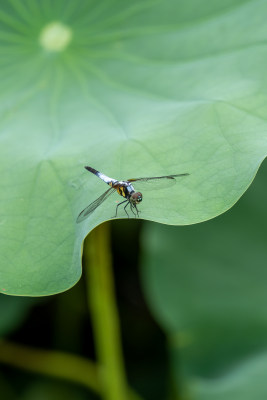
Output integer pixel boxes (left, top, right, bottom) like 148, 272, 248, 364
143, 159, 267, 400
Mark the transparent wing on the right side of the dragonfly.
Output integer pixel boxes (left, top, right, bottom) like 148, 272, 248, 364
127, 173, 189, 190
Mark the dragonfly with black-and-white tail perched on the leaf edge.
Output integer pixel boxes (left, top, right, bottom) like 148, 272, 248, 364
76, 166, 189, 223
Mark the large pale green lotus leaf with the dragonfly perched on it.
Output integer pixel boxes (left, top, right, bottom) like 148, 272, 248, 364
0, 0, 267, 295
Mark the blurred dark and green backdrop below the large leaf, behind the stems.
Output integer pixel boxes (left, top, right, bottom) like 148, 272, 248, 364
0, 157, 267, 400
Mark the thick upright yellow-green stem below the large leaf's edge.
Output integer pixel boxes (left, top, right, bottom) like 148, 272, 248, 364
84, 223, 143, 400
